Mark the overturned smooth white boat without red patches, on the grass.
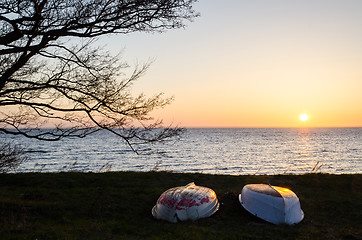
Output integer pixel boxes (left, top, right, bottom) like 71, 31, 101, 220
239, 184, 304, 225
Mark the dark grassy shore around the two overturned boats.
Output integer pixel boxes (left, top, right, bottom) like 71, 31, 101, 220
0, 172, 362, 240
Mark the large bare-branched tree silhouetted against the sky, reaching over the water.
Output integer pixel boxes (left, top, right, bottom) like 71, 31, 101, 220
0, 0, 198, 152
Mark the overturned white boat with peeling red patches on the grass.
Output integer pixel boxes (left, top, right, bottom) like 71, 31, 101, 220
152, 183, 219, 223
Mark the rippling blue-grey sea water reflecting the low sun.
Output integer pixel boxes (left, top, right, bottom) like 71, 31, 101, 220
0, 128, 362, 175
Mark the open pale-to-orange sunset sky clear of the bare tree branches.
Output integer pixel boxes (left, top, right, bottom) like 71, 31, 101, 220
102, 0, 362, 127
